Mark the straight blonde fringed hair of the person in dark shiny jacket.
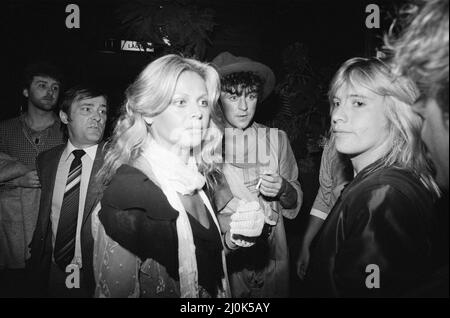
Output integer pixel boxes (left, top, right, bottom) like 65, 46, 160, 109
328, 57, 439, 195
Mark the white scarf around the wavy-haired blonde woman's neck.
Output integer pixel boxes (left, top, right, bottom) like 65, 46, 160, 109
136, 139, 230, 298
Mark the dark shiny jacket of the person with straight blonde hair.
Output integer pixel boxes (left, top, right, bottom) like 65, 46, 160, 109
307, 162, 435, 297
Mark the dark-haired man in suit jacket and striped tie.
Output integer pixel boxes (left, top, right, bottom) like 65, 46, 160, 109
30, 86, 107, 297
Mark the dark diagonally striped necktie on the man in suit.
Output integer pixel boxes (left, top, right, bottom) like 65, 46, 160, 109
53, 150, 85, 271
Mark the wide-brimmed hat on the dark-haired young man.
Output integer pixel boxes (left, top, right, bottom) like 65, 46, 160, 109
212, 52, 275, 100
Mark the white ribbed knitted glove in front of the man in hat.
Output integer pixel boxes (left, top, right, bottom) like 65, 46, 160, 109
230, 201, 265, 237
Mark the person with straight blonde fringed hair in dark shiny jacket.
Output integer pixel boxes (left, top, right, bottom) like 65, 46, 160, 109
307, 58, 437, 297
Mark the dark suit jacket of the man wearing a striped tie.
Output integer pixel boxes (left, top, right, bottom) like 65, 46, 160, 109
28, 143, 103, 294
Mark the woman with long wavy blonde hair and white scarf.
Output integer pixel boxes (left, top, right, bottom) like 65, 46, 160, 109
93, 55, 262, 297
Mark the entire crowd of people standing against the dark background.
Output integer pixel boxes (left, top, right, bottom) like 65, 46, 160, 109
0, 0, 449, 298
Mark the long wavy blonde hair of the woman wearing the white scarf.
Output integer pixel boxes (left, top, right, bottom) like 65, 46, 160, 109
97, 54, 222, 186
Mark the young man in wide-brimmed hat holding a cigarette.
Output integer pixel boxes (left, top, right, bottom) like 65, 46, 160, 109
212, 52, 303, 297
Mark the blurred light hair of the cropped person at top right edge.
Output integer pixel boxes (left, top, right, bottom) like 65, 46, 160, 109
384, 0, 449, 114
